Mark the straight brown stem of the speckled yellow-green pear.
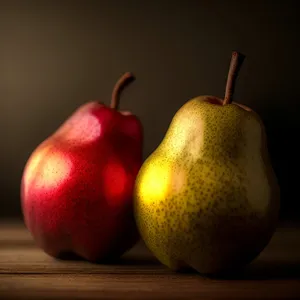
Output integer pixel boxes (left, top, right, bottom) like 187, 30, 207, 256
223, 51, 245, 105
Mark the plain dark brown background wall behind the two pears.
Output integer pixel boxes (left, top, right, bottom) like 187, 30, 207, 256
0, 0, 300, 218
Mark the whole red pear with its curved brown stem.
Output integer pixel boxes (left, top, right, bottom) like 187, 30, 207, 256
21, 73, 143, 261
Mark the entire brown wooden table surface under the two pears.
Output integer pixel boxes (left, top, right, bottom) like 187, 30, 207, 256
0, 222, 300, 300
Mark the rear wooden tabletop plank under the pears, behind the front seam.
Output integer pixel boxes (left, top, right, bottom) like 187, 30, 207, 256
0, 227, 300, 277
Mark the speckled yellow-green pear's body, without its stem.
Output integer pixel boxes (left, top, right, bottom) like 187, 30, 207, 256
134, 96, 279, 274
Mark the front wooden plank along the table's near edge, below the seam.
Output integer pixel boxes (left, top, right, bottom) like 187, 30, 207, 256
0, 274, 299, 299
